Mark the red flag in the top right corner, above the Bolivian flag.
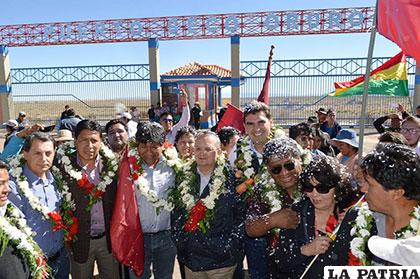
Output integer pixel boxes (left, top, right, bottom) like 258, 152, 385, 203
377, 0, 420, 63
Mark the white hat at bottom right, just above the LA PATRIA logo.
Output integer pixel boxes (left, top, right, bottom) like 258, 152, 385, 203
368, 235, 420, 266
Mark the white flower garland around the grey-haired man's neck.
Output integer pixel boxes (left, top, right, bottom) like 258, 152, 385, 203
179, 154, 226, 211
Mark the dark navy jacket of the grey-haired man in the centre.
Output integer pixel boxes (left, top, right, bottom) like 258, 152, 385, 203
171, 169, 245, 271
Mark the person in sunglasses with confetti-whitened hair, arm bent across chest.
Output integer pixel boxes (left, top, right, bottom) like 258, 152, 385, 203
245, 137, 311, 278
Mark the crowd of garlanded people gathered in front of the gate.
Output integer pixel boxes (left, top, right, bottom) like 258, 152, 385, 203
0, 93, 420, 279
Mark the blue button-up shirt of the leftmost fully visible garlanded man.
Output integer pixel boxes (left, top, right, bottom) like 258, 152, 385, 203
9, 165, 64, 257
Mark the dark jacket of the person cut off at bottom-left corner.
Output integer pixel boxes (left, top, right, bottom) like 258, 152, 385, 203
0, 246, 30, 279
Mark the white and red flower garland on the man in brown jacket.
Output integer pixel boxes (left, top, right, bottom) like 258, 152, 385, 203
51, 142, 118, 241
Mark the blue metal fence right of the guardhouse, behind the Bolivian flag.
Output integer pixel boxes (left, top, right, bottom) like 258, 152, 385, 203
241, 57, 415, 126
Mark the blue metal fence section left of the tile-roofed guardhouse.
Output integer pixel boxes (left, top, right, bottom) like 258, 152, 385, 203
12, 64, 150, 122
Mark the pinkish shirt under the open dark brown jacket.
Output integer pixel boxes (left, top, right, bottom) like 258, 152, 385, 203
77, 156, 105, 236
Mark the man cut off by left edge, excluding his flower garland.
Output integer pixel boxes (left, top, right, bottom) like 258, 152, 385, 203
0, 161, 29, 279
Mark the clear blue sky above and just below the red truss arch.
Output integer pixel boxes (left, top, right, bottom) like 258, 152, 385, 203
0, 0, 399, 73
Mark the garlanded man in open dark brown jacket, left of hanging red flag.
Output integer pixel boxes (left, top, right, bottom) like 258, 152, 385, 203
57, 119, 119, 278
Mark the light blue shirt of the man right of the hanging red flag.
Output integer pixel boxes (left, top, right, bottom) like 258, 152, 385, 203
136, 158, 175, 233
